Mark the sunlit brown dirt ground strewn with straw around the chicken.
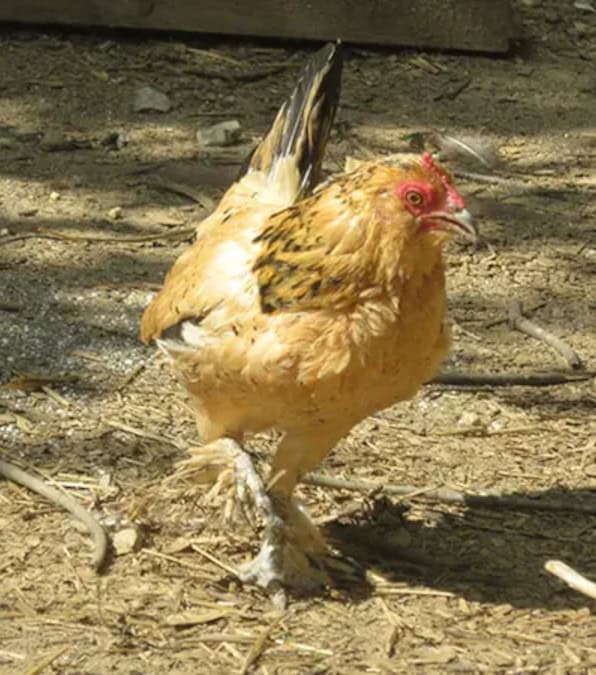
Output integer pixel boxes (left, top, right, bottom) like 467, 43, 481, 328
0, 0, 596, 675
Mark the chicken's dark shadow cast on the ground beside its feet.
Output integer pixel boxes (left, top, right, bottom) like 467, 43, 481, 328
326, 489, 596, 610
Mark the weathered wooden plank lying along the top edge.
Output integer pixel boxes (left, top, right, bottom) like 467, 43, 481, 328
0, 0, 513, 52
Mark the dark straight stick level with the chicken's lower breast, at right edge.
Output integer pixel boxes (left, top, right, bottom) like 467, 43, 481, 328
427, 372, 594, 387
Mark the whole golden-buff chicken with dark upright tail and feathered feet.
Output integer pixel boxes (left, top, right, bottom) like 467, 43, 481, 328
141, 45, 475, 604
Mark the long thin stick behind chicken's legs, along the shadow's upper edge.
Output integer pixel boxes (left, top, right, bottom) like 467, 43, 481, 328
302, 473, 596, 515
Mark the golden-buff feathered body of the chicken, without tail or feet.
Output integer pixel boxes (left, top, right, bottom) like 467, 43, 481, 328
142, 42, 474, 600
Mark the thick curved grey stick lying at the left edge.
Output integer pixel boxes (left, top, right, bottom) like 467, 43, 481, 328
0, 459, 109, 572
